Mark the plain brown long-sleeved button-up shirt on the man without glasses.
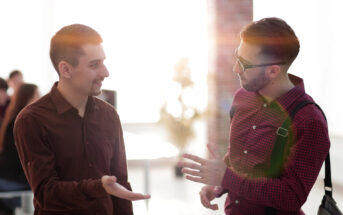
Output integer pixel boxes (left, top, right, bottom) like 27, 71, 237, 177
14, 83, 133, 215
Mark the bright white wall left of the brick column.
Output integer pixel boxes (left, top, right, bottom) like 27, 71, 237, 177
0, 0, 208, 122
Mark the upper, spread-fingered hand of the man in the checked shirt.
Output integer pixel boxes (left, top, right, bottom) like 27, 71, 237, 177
178, 144, 227, 186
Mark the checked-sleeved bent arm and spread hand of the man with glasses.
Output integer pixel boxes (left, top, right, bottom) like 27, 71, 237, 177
180, 119, 330, 211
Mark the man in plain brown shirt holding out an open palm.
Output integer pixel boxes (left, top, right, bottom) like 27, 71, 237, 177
14, 24, 150, 215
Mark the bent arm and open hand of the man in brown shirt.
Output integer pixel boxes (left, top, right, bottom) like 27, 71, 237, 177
14, 116, 146, 211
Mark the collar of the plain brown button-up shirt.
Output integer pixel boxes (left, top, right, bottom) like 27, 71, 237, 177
50, 82, 97, 114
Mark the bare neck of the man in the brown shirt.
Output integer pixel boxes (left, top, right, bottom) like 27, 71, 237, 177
57, 81, 88, 117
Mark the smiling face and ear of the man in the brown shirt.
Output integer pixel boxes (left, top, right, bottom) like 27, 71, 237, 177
61, 44, 109, 96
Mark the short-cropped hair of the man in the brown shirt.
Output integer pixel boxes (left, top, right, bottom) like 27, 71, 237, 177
50, 24, 102, 73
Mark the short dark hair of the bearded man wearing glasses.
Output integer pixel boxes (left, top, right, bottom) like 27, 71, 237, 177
240, 17, 300, 64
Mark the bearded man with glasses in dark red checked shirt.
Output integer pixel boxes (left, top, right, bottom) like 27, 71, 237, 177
179, 18, 330, 215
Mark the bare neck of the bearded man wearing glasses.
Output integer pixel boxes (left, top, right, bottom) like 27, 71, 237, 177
259, 76, 294, 103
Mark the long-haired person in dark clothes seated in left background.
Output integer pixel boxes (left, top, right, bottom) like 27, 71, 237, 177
0, 84, 39, 213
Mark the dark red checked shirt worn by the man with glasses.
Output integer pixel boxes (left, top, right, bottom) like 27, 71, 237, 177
222, 75, 330, 215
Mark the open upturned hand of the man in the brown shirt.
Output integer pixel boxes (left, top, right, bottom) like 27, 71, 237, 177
101, 175, 150, 201
